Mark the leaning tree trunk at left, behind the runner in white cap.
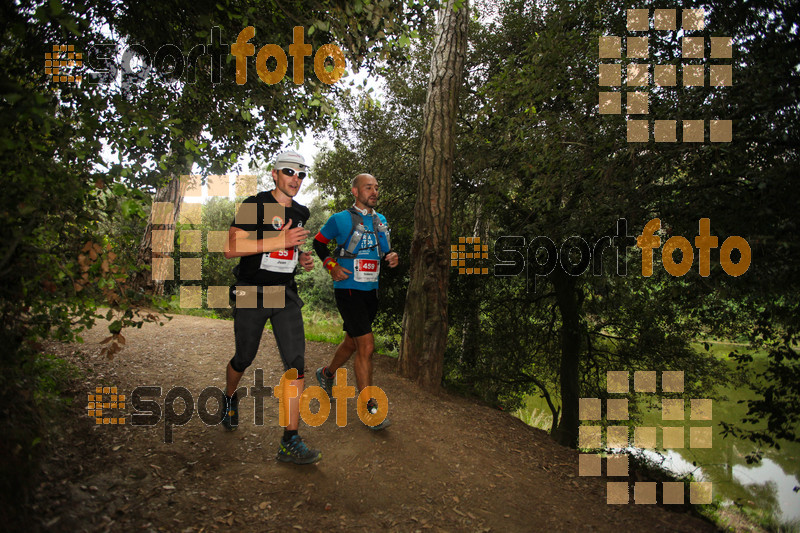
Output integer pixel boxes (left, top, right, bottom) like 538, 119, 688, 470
132, 175, 188, 295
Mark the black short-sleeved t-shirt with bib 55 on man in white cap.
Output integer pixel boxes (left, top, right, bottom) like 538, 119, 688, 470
231, 191, 310, 285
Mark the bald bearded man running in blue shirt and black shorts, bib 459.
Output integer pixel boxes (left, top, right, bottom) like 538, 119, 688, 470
314, 174, 399, 430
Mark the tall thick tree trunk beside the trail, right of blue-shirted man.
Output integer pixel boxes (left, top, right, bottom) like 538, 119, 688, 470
399, 0, 469, 390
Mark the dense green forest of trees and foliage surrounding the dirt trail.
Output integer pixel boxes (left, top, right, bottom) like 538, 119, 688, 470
0, 0, 800, 524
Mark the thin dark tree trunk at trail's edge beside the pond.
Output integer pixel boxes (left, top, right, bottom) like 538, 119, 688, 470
552, 267, 581, 448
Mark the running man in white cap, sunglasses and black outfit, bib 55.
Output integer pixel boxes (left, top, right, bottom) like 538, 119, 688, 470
222, 151, 322, 464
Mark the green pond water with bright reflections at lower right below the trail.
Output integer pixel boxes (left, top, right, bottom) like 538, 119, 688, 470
516, 356, 800, 523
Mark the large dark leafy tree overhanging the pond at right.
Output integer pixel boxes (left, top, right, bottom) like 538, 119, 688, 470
466, 0, 798, 446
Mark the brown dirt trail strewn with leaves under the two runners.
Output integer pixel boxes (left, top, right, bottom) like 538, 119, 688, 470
30, 316, 714, 532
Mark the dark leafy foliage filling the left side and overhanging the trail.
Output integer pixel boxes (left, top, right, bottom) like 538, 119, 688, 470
0, 0, 432, 529
